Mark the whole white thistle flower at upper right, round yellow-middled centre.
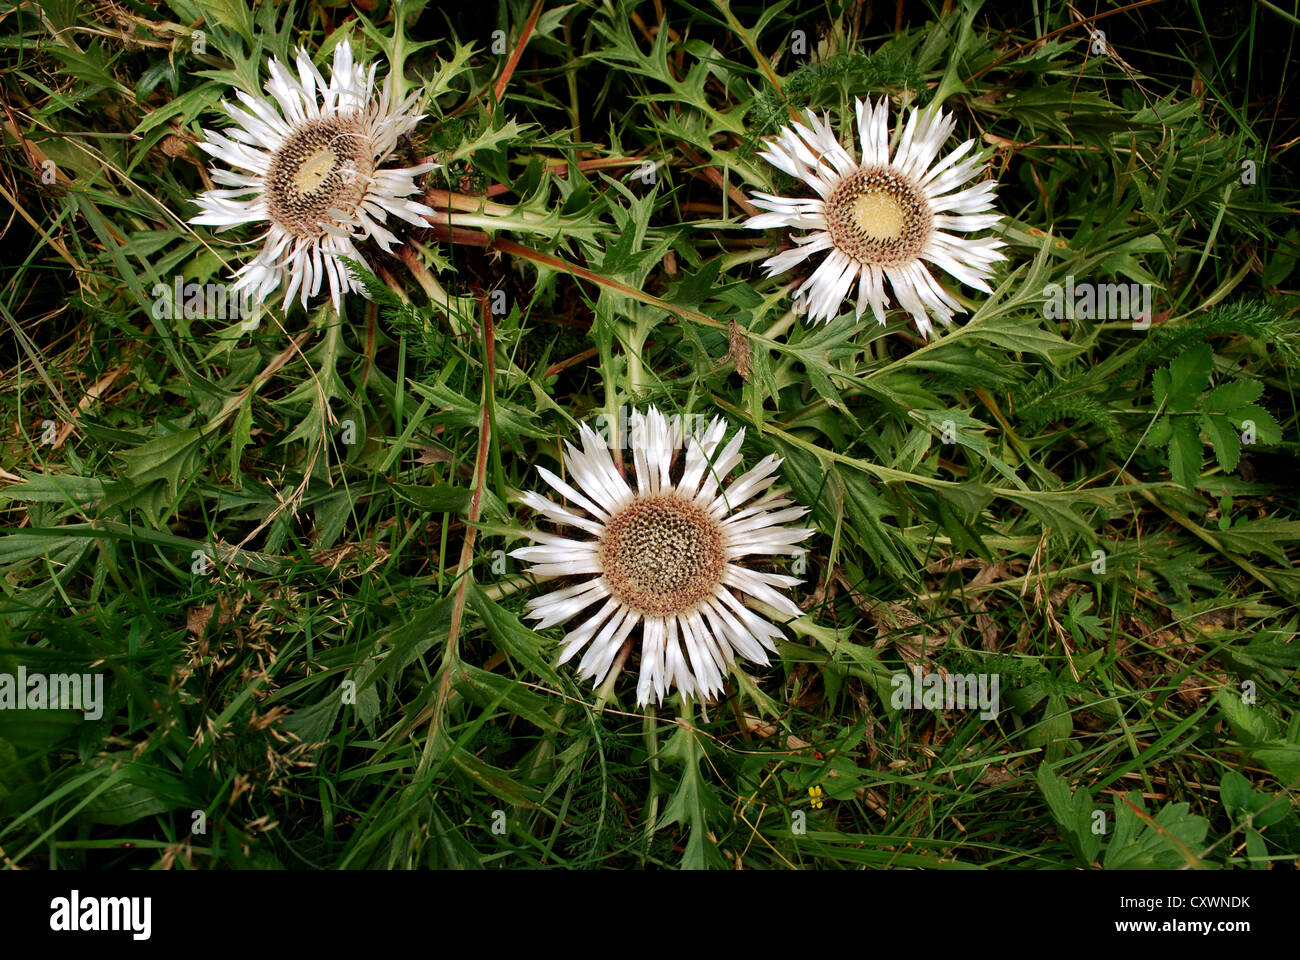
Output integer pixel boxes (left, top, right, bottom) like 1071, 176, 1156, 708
745, 98, 1006, 337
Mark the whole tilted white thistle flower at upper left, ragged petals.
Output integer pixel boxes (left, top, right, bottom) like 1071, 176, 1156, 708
190, 42, 437, 311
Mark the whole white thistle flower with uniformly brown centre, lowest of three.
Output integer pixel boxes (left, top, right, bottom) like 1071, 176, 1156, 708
511, 407, 814, 706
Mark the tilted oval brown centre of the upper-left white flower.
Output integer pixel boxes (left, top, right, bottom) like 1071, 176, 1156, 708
267, 120, 374, 238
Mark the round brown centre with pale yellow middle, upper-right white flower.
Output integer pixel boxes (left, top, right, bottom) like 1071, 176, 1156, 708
826, 167, 933, 267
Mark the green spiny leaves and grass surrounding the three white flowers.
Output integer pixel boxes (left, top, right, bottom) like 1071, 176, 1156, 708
0, 0, 1300, 869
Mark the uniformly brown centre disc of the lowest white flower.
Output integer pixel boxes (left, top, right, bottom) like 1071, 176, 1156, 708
601, 494, 727, 617
